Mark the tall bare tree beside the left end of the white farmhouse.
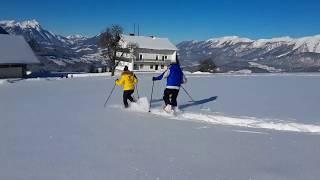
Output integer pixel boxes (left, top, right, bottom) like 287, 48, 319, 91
98, 25, 123, 76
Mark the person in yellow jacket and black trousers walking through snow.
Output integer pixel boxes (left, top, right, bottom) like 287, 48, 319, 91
116, 66, 138, 108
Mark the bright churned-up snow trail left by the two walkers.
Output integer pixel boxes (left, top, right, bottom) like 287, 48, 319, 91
110, 97, 320, 135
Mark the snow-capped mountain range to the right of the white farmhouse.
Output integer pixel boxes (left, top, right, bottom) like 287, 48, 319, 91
177, 35, 320, 72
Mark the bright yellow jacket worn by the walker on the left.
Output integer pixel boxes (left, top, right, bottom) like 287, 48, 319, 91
116, 71, 138, 91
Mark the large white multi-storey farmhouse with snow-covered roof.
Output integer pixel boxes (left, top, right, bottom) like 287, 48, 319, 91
117, 34, 178, 72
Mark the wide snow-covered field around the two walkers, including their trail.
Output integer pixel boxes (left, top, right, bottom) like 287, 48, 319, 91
0, 74, 320, 180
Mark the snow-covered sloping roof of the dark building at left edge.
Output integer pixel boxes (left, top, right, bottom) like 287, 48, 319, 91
0, 34, 40, 64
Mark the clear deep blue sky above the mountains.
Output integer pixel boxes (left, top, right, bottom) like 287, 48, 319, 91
0, 0, 320, 43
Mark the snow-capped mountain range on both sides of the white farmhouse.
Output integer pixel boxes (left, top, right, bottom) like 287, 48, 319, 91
0, 20, 320, 72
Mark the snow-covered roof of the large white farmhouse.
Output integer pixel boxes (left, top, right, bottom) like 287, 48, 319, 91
122, 35, 178, 51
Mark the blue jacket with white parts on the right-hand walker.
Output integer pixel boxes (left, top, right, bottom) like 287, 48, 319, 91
154, 64, 186, 88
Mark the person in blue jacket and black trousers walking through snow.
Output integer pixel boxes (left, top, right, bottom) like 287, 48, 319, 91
152, 61, 187, 111
